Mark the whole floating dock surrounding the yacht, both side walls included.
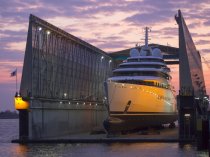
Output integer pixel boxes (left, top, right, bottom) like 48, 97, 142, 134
16, 11, 210, 148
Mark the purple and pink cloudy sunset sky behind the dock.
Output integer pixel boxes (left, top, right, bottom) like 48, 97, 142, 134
0, 0, 210, 111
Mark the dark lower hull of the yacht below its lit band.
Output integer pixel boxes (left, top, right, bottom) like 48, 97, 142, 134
104, 113, 178, 133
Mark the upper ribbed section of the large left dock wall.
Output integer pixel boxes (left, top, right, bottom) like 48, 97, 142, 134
20, 15, 113, 102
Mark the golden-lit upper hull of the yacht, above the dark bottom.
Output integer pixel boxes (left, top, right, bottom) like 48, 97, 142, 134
107, 82, 177, 113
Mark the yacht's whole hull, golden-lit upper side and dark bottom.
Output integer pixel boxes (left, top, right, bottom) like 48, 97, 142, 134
104, 81, 178, 132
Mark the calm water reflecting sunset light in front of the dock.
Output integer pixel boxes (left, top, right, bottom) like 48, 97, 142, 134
0, 119, 208, 157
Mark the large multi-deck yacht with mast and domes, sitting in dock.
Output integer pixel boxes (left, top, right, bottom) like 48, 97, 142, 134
104, 27, 177, 132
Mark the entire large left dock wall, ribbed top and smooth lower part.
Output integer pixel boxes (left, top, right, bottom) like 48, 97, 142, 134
19, 15, 113, 139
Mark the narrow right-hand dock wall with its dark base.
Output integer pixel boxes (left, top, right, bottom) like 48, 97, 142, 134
175, 10, 209, 149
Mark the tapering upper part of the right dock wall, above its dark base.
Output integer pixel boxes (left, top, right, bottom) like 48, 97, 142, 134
175, 10, 206, 96
